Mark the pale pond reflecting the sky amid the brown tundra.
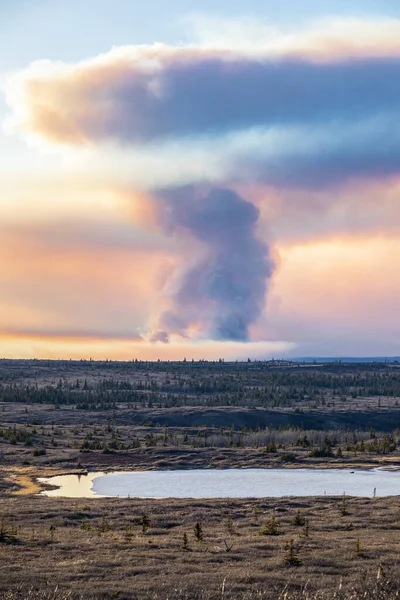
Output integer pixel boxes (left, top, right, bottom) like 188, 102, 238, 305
39, 469, 400, 498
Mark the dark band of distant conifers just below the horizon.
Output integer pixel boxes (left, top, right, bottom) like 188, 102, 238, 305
0, 361, 400, 410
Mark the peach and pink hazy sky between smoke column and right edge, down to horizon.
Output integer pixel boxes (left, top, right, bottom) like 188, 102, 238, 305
248, 235, 400, 356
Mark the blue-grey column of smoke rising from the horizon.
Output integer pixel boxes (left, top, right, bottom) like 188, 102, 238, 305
150, 186, 273, 342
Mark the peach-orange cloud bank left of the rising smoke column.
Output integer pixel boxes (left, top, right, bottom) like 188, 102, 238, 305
0, 223, 174, 338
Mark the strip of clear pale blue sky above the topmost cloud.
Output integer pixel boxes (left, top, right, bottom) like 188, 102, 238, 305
0, 0, 400, 70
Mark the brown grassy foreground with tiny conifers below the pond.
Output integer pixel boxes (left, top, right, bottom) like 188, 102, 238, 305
0, 495, 400, 600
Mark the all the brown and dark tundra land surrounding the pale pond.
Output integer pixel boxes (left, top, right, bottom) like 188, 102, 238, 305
0, 361, 400, 600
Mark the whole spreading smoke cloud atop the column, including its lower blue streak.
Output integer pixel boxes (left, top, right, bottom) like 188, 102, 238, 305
7, 24, 400, 187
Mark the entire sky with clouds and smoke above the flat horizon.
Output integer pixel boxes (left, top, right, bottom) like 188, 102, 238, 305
0, 0, 400, 360
